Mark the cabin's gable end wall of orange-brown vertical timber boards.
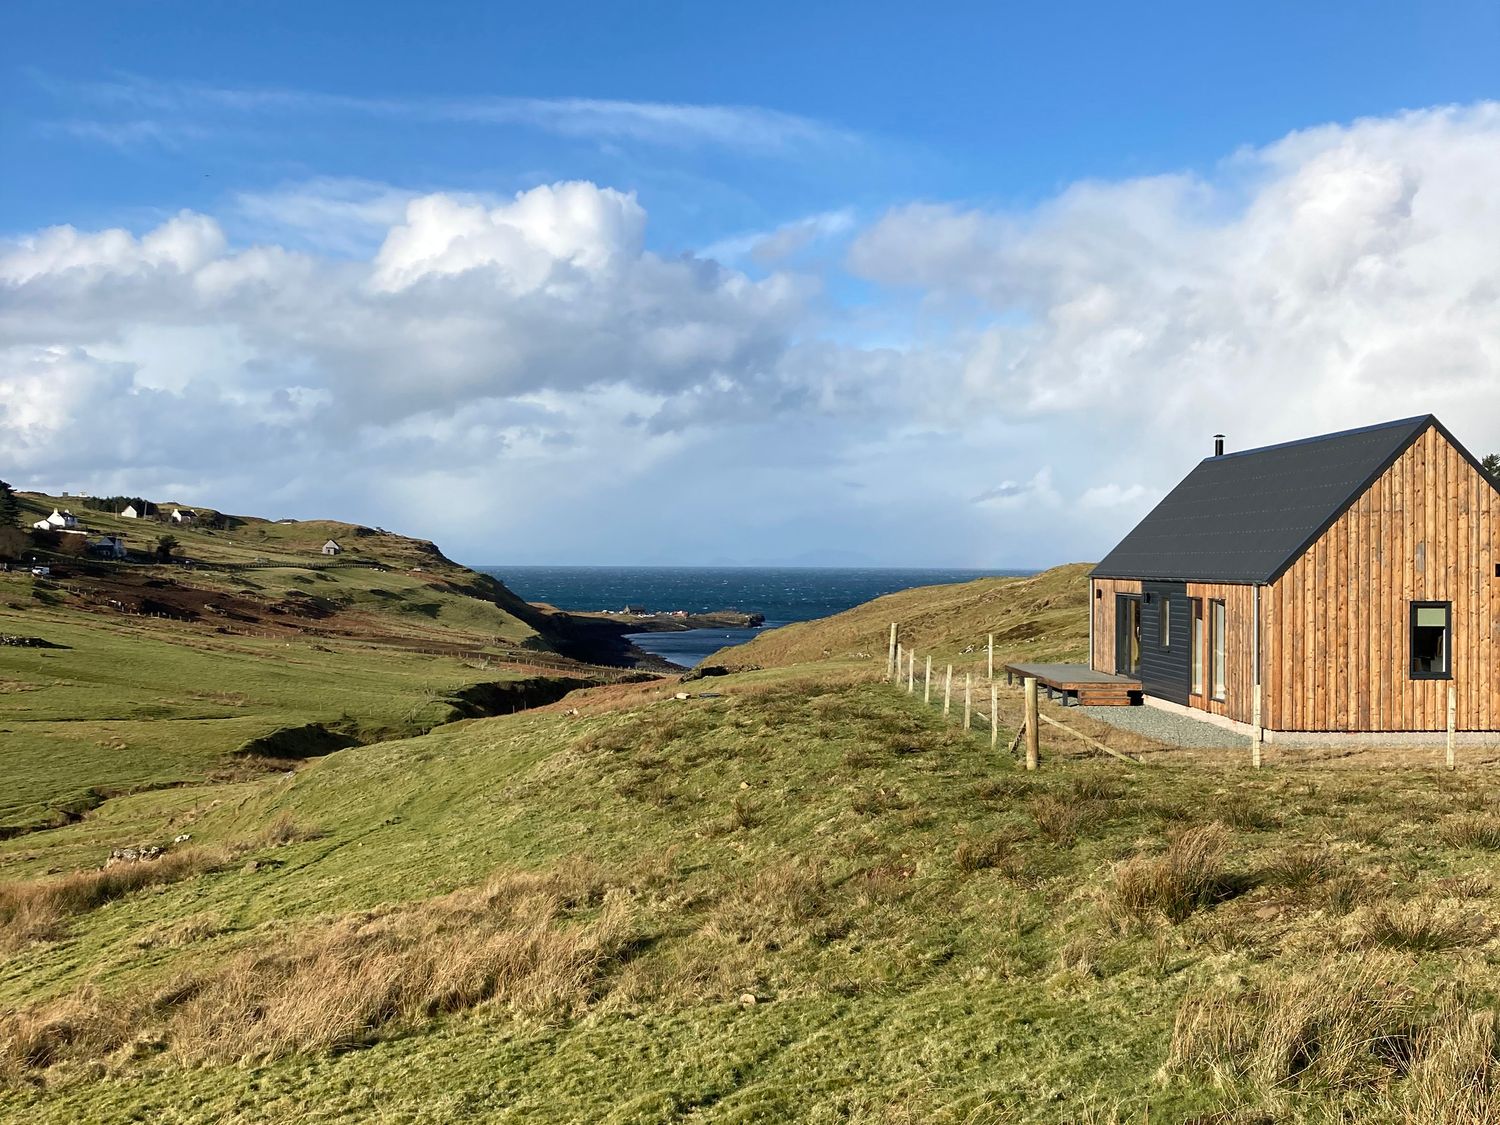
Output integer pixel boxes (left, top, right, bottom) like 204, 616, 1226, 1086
1266, 426, 1500, 731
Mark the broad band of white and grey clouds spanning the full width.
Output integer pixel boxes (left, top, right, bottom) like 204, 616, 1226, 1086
0, 105, 1500, 566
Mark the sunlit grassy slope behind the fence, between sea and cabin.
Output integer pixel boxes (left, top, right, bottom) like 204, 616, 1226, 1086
704, 563, 1089, 669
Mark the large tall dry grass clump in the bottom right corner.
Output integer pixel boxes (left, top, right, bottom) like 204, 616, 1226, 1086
1166, 957, 1500, 1125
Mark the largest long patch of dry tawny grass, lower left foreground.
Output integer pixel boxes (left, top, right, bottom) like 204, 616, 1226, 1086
0, 863, 632, 1082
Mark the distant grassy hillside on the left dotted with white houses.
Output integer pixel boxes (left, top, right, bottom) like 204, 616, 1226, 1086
0, 494, 639, 834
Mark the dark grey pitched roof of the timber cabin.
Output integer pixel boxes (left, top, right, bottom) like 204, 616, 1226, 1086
1094, 414, 1434, 582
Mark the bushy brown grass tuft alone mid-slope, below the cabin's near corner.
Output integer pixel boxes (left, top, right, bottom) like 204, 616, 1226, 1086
1110, 824, 1236, 923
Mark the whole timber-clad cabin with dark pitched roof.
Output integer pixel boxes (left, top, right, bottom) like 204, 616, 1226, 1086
1089, 416, 1500, 737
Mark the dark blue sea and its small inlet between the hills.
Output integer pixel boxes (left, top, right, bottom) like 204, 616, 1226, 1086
474, 566, 1035, 668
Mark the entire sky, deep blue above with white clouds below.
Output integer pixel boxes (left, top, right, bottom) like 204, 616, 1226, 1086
0, 3, 1500, 566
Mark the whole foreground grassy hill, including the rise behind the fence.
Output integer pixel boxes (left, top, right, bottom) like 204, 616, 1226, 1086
0, 569, 1500, 1125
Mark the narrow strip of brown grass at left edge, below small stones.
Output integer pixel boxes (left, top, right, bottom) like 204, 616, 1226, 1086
0, 846, 237, 953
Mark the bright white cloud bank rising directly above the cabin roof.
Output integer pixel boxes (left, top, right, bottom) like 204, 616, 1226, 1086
849, 104, 1500, 456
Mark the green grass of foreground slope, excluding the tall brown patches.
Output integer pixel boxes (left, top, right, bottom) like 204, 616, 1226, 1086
0, 668, 1500, 1122
